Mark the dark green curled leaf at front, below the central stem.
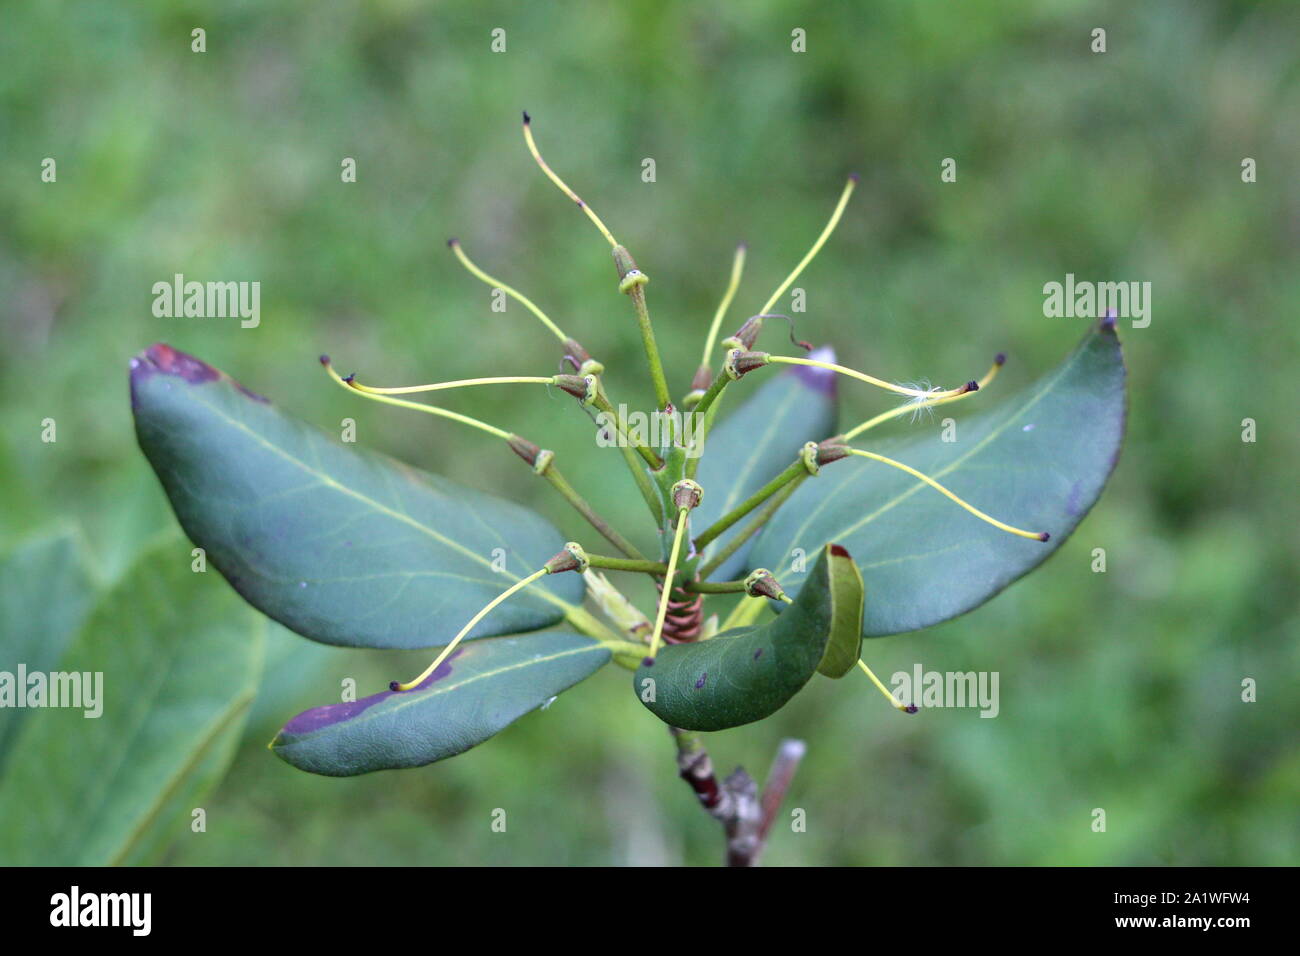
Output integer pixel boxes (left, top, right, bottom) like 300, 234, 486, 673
632, 545, 857, 731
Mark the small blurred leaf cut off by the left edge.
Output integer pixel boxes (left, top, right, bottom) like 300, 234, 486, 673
0, 529, 94, 771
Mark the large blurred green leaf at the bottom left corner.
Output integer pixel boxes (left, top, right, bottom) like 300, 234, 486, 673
0, 540, 264, 866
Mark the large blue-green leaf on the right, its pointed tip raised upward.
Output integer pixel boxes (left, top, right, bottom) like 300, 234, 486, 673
750, 324, 1125, 637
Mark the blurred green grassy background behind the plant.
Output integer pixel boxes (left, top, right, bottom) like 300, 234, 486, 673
0, 0, 1300, 865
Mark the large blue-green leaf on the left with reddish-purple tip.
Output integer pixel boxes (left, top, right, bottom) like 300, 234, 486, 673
131, 345, 582, 648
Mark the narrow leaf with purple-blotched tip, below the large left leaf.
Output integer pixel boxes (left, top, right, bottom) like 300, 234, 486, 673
270, 631, 610, 777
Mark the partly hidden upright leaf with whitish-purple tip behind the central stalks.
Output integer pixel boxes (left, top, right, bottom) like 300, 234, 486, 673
690, 349, 835, 581
